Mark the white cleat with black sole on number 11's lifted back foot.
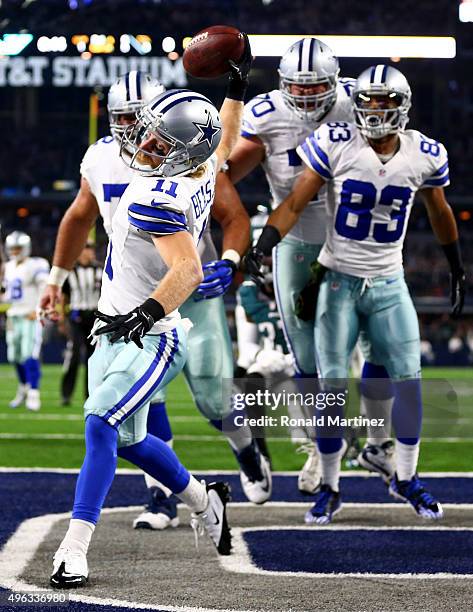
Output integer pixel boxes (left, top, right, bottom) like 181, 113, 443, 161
191, 481, 232, 555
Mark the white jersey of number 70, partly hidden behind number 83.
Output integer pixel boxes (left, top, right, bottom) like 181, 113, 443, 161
241, 79, 355, 244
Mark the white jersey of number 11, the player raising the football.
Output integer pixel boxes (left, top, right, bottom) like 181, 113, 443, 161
98, 155, 217, 333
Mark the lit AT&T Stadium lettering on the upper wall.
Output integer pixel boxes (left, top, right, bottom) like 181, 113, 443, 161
0, 56, 187, 87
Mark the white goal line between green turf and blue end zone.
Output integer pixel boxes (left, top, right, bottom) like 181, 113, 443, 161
0, 466, 473, 478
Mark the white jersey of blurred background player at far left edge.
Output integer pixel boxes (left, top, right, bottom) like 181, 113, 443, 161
4, 257, 49, 317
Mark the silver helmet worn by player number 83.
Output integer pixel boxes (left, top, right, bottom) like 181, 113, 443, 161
352, 64, 411, 140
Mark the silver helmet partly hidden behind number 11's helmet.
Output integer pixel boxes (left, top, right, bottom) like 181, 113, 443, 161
107, 70, 164, 142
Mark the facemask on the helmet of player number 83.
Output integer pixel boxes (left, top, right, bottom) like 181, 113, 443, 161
353, 90, 411, 140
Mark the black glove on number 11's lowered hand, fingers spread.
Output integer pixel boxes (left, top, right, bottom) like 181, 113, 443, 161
94, 298, 165, 348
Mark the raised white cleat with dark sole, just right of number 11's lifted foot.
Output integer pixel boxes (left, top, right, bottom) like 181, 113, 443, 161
237, 442, 273, 504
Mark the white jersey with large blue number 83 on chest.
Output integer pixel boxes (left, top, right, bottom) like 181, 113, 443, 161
297, 123, 449, 278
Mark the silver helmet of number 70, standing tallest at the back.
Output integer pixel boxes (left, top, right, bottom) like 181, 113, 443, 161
278, 38, 340, 121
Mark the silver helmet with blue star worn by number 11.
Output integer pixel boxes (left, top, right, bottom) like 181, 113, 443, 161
120, 89, 222, 177
